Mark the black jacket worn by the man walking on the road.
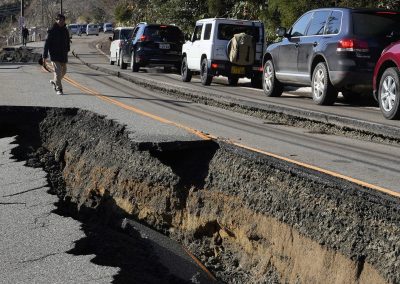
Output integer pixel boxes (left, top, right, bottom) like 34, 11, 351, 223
43, 23, 70, 63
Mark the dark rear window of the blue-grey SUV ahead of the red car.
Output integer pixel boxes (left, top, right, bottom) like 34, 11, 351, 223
353, 12, 400, 37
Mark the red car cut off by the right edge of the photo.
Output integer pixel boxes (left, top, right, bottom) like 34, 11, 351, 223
373, 41, 400, 119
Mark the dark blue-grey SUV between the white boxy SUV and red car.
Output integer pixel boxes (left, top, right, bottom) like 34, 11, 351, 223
263, 8, 400, 105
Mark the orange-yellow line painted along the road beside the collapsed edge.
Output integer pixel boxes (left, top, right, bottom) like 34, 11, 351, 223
64, 73, 400, 197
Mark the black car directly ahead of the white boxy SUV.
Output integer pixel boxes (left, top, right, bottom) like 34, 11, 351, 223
120, 23, 184, 72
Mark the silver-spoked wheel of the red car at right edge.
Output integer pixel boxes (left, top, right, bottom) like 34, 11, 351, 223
378, 67, 400, 119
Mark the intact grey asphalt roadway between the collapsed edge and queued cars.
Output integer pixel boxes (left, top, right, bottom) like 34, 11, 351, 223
10, 34, 400, 192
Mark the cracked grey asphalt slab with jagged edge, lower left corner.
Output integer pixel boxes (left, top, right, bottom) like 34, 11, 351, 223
0, 138, 119, 283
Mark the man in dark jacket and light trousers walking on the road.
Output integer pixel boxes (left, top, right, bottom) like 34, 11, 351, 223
43, 14, 70, 95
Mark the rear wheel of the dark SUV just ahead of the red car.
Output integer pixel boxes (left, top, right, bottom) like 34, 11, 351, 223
311, 62, 338, 105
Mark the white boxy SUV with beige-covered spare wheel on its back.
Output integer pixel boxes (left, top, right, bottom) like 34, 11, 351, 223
181, 18, 265, 87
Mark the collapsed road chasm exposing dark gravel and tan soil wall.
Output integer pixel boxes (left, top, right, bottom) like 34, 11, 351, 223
0, 107, 400, 283
